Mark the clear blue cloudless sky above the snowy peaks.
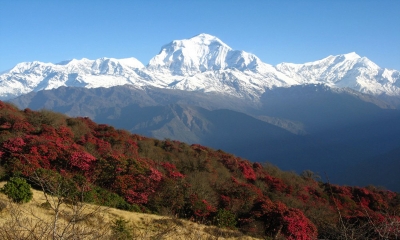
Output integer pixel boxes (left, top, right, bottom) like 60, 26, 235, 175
0, 0, 400, 72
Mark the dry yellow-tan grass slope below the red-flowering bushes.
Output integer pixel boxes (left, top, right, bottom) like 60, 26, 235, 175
0, 182, 252, 240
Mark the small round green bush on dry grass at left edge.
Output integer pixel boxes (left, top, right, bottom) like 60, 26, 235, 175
1, 177, 33, 203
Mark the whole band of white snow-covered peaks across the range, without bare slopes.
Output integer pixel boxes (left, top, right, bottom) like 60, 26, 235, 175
0, 34, 400, 100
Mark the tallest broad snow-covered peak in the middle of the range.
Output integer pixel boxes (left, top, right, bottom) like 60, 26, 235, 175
148, 34, 263, 76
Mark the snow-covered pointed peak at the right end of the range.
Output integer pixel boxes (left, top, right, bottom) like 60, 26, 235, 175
276, 52, 400, 96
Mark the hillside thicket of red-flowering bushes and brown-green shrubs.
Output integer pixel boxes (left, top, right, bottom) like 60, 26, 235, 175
0, 102, 400, 239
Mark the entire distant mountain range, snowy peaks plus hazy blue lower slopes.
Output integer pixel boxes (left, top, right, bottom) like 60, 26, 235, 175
0, 34, 400, 191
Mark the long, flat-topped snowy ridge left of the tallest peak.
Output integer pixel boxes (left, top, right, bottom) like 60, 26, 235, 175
0, 58, 148, 99
